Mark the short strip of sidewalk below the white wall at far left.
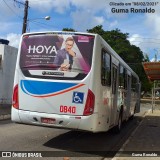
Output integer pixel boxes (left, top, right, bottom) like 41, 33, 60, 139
0, 105, 11, 121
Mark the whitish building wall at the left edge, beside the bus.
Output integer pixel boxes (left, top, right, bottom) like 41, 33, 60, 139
0, 39, 18, 106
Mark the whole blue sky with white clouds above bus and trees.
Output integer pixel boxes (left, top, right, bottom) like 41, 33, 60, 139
0, 0, 160, 61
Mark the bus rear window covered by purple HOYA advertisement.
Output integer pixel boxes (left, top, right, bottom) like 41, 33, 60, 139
20, 32, 95, 78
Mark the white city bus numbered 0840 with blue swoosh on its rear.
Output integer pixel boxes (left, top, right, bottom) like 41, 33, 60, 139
11, 31, 140, 132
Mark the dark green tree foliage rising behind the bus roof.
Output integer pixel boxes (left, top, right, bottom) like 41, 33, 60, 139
87, 25, 152, 92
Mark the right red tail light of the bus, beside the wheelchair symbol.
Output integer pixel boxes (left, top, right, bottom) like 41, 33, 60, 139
83, 90, 95, 116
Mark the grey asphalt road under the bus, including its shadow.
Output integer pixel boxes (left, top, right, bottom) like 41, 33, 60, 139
0, 105, 150, 160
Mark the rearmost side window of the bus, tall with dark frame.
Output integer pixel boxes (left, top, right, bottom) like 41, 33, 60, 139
101, 50, 111, 86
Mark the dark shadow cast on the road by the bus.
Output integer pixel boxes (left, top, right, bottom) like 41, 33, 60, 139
44, 116, 142, 157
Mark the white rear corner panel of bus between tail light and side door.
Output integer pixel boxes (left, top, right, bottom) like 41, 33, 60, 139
79, 37, 111, 132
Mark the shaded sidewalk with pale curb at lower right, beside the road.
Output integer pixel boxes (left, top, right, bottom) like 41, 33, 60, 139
112, 109, 160, 160
